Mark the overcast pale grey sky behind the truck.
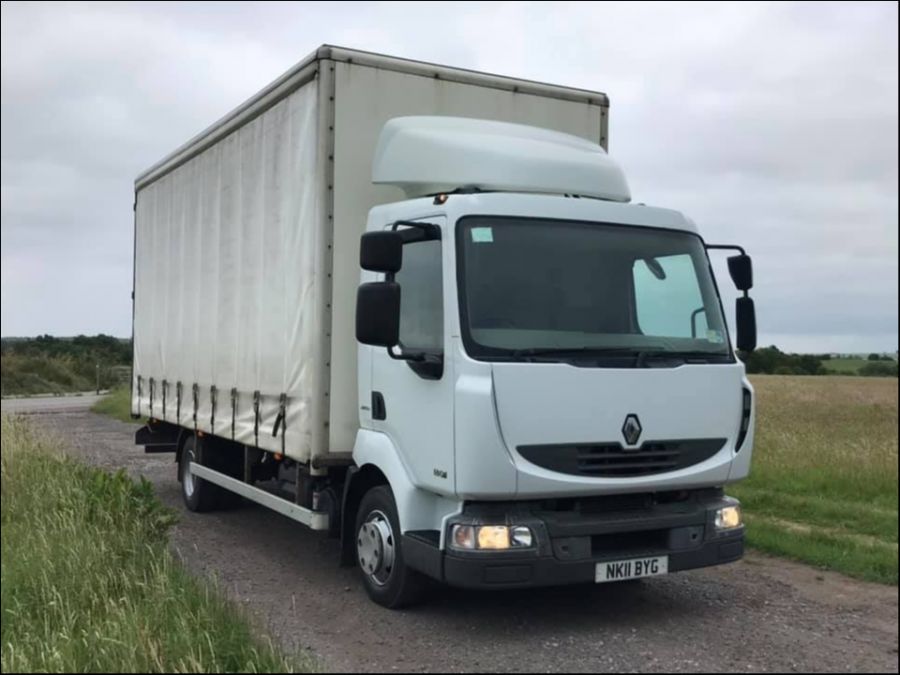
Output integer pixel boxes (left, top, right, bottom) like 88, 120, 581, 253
0, 2, 898, 352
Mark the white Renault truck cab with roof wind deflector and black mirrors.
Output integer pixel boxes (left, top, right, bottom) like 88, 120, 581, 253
345, 118, 755, 605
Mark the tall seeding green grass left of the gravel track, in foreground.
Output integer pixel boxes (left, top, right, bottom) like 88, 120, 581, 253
0, 417, 306, 672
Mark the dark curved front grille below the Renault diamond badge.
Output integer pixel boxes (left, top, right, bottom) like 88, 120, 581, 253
516, 438, 726, 478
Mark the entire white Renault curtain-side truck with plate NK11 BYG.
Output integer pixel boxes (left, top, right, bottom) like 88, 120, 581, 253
132, 46, 756, 607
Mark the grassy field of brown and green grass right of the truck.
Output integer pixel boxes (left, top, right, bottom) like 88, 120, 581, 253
729, 375, 898, 585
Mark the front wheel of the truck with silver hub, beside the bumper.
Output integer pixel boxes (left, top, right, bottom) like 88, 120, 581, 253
355, 485, 426, 609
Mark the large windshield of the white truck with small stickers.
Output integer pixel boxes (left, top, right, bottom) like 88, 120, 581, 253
457, 216, 731, 363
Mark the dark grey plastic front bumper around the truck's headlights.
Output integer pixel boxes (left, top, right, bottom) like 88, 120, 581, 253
403, 492, 744, 589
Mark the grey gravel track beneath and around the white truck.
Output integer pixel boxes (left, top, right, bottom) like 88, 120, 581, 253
15, 412, 898, 672
